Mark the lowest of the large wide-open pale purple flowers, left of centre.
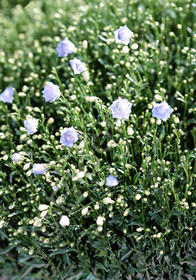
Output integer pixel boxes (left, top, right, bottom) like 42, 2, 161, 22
60, 127, 78, 147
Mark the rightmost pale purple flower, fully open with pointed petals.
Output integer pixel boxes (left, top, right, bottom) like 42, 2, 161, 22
152, 101, 174, 121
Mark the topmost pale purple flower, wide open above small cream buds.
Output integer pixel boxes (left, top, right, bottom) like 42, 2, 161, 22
114, 25, 133, 45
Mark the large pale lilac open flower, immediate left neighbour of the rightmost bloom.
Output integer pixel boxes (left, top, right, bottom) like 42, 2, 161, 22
109, 97, 132, 119
